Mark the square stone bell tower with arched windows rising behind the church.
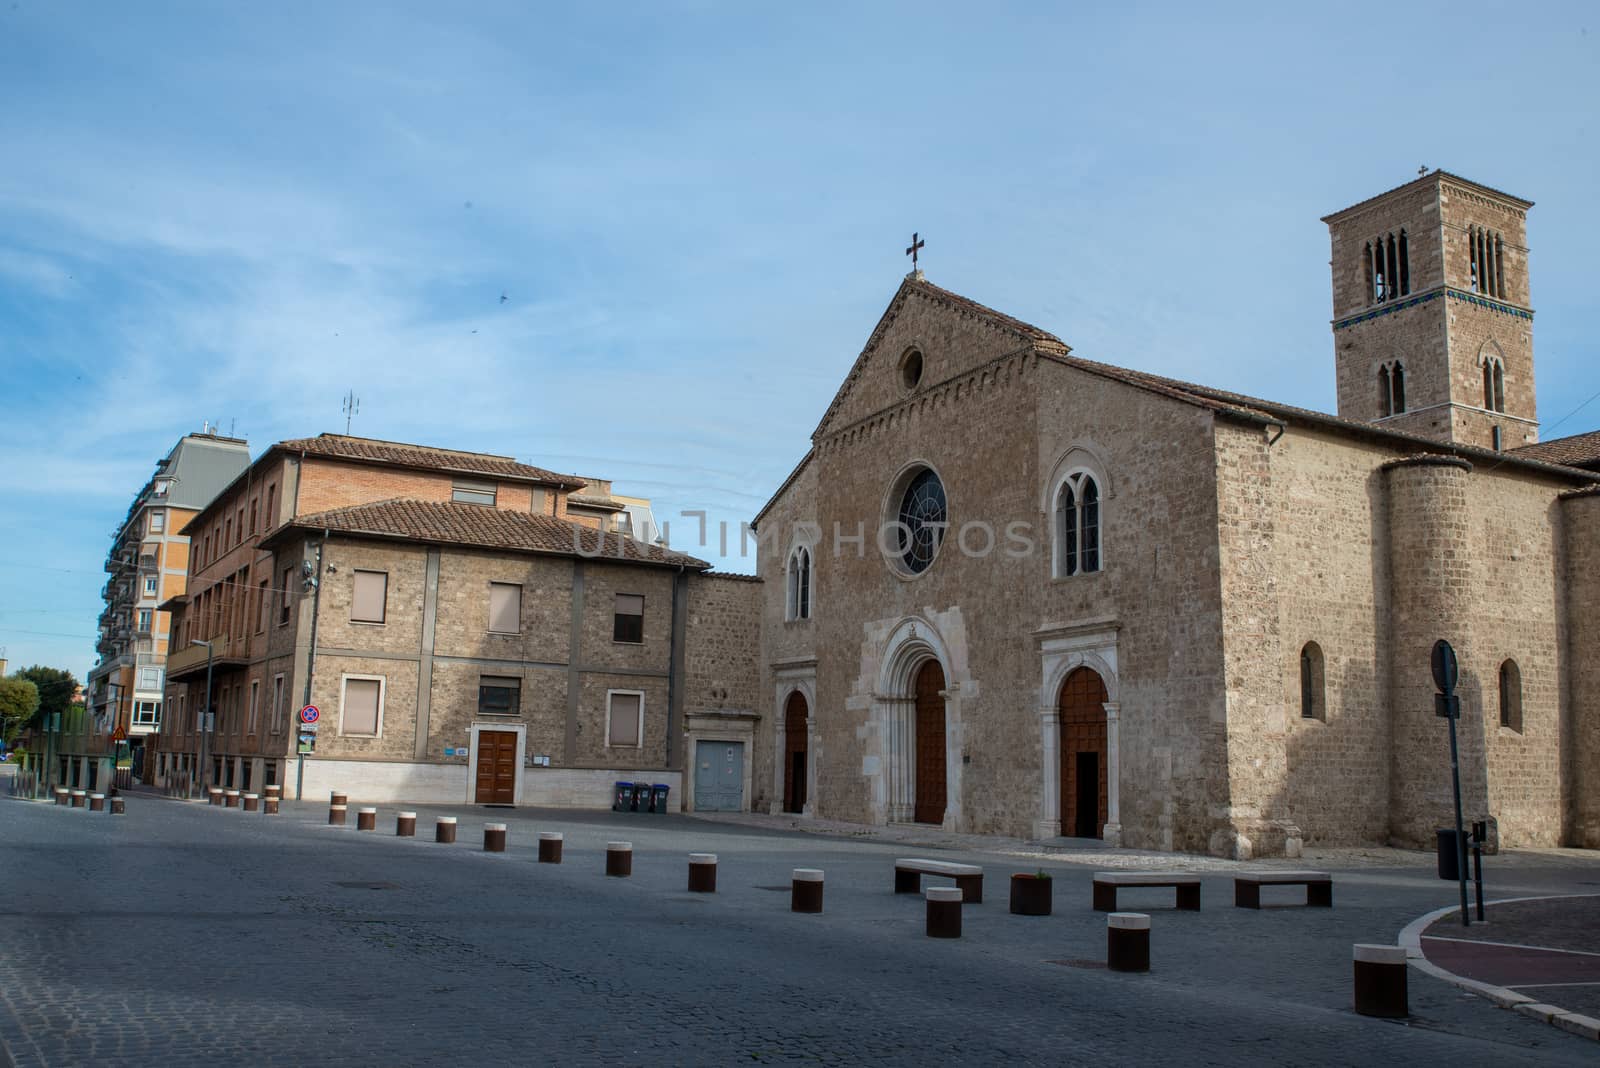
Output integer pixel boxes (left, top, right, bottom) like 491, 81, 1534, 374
1323, 171, 1539, 449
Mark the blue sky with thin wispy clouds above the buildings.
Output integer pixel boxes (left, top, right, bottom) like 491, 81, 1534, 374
0, 0, 1600, 675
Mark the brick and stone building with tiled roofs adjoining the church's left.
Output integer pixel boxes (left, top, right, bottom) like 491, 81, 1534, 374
157, 435, 758, 806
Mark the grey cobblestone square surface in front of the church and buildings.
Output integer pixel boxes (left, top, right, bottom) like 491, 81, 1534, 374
0, 796, 1600, 1065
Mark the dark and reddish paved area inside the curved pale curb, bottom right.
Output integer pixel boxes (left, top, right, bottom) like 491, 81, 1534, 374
1400, 894, 1600, 1041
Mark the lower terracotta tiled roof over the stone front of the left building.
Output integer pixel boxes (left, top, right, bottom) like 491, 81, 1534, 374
278, 497, 710, 571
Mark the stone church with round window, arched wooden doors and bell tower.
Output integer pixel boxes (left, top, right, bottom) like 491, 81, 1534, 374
750, 171, 1600, 857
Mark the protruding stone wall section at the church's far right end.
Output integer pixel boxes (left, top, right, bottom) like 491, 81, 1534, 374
1560, 491, 1600, 849
